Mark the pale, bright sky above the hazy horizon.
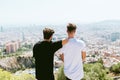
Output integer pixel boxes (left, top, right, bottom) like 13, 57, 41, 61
0, 0, 120, 24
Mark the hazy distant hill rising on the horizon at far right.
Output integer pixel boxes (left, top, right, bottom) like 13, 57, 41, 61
79, 20, 120, 32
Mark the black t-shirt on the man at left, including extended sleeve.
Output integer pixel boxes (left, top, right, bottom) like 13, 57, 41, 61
33, 41, 62, 80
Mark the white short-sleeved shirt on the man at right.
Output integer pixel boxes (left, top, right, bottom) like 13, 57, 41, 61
60, 38, 85, 80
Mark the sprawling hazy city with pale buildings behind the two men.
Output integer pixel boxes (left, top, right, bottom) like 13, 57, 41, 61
0, 20, 120, 79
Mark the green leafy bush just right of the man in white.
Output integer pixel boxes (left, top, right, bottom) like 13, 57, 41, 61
82, 63, 112, 80
